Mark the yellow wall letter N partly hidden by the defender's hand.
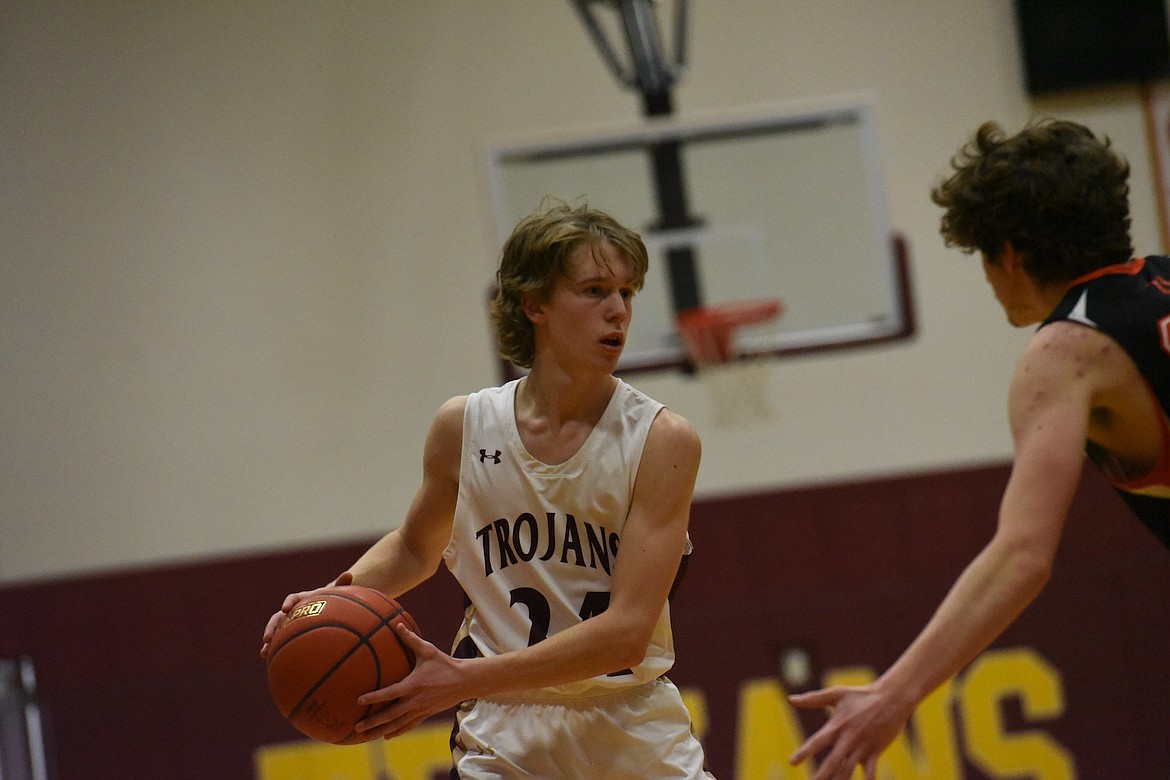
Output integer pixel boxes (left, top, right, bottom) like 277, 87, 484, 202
824, 667, 963, 780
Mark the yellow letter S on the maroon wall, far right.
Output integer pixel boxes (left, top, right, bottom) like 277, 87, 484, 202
959, 648, 1076, 780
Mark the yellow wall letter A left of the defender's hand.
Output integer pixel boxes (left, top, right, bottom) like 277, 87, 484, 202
735, 679, 812, 780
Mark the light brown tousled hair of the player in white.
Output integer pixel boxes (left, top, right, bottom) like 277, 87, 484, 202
491, 199, 649, 368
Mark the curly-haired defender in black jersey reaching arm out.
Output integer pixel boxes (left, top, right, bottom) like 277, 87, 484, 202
791, 119, 1170, 780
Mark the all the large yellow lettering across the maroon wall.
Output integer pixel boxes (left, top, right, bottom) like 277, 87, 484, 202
255, 648, 1076, 780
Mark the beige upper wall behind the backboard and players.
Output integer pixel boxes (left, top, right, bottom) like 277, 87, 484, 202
0, 0, 1162, 581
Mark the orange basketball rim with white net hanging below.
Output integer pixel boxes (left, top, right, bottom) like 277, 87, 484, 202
675, 298, 783, 426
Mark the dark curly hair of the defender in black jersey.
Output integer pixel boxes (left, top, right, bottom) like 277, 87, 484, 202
930, 119, 1133, 285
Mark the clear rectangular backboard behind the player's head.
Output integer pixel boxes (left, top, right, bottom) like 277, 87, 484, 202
487, 96, 914, 373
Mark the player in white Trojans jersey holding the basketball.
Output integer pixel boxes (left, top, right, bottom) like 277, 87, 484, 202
264, 205, 711, 780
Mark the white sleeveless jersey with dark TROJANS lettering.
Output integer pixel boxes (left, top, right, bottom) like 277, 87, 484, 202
443, 379, 674, 697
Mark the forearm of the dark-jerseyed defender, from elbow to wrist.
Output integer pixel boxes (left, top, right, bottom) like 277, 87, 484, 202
878, 540, 1051, 704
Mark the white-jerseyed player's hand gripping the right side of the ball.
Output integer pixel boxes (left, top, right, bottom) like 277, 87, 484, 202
356, 623, 467, 739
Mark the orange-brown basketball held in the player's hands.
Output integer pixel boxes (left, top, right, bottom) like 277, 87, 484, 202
267, 585, 419, 745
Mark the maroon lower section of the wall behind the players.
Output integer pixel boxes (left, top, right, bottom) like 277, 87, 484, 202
0, 465, 1170, 780
